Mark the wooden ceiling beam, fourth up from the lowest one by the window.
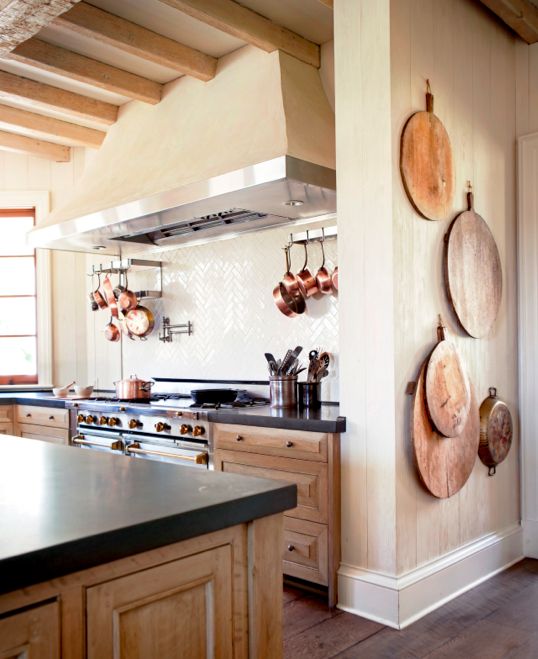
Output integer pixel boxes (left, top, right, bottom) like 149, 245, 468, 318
8, 37, 162, 104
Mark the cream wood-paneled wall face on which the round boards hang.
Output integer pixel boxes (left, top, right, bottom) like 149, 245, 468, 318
391, 0, 526, 574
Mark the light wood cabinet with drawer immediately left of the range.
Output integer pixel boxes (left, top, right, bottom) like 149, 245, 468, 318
14, 405, 69, 444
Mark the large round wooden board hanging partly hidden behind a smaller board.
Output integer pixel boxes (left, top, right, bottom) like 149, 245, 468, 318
411, 364, 480, 499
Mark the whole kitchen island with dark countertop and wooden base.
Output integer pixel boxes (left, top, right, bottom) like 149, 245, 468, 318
0, 436, 296, 659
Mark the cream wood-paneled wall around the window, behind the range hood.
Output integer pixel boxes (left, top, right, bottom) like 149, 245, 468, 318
0, 149, 87, 384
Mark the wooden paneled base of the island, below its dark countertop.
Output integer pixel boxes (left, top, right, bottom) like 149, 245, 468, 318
0, 513, 282, 659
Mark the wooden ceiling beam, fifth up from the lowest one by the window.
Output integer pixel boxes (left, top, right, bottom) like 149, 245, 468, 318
53, 2, 217, 81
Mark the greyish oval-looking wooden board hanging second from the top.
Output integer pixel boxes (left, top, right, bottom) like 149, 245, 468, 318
445, 193, 502, 339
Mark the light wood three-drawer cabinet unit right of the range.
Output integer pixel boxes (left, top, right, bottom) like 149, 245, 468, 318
213, 424, 340, 606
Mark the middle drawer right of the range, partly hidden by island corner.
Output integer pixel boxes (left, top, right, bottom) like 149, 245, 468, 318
215, 451, 328, 522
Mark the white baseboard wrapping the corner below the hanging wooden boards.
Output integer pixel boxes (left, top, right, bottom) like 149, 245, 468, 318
338, 524, 520, 629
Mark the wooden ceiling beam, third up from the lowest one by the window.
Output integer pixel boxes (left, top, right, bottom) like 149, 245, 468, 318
0, 71, 118, 126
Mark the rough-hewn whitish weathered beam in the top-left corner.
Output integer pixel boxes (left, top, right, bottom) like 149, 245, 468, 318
0, 0, 78, 57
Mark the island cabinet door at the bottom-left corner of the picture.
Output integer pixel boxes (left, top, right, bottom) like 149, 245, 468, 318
0, 602, 60, 659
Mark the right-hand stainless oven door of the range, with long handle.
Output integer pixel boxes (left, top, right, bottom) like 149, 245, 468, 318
123, 434, 209, 469
